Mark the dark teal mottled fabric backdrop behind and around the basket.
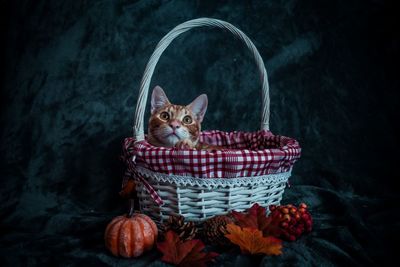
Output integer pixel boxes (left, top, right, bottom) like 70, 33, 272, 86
0, 0, 400, 266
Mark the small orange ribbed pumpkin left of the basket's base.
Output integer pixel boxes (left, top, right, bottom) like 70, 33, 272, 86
104, 212, 158, 258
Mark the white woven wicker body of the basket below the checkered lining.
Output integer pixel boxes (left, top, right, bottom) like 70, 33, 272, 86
136, 168, 291, 222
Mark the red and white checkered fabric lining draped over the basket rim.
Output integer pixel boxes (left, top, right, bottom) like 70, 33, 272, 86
123, 130, 301, 178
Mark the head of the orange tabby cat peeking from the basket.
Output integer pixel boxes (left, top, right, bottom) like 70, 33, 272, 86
148, 86, 208, 147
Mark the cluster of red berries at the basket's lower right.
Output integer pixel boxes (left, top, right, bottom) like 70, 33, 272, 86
269, 203, 312, 241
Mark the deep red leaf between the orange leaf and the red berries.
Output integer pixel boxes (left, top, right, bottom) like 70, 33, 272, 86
232, 203, 280, 237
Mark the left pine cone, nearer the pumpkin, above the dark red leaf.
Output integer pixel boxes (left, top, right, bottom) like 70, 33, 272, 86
162, 215, 198, 241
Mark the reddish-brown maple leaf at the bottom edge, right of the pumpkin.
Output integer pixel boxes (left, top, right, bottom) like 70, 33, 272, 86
157, 230, 218, 267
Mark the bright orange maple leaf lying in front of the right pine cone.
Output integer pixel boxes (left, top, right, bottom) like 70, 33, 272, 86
225, 223, 282, 255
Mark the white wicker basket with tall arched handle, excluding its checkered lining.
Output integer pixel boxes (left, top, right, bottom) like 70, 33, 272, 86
128, 18, 300, 223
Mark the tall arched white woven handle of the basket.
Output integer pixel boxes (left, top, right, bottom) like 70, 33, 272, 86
133, 18, 270, 141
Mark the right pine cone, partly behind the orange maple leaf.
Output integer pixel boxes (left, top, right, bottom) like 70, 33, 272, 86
203, 215, 233, 246
